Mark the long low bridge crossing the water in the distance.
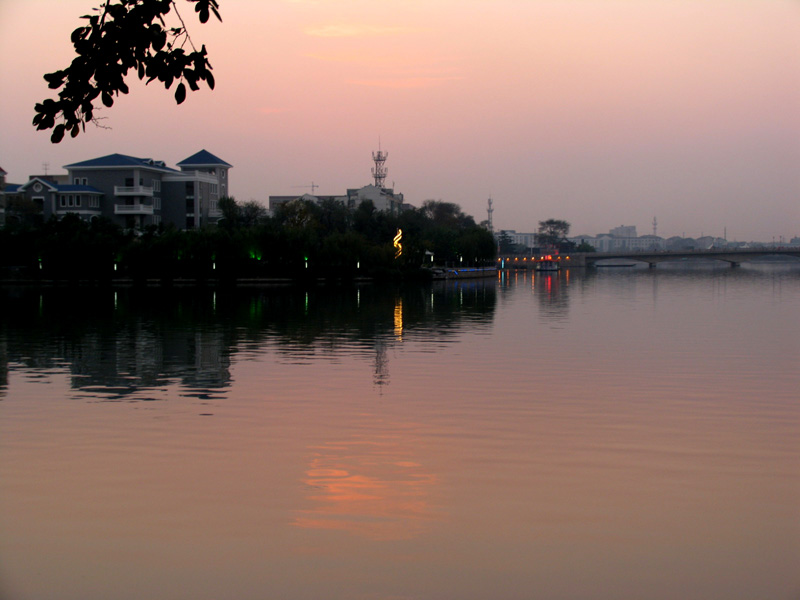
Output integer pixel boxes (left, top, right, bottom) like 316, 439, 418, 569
497, 248, 800, 269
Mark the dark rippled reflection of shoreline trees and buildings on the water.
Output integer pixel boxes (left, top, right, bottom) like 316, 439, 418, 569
0, 280, 495, 400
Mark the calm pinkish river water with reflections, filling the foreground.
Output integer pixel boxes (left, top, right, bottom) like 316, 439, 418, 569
0, 265, 800, 600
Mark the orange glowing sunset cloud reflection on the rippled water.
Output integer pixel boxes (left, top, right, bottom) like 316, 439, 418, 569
294, 435, 436, 540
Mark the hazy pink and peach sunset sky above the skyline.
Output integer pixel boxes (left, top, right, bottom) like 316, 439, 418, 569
0, 0, 800, 241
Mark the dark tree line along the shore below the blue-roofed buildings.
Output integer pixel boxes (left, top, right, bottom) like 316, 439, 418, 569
0, 198, 496, 282
